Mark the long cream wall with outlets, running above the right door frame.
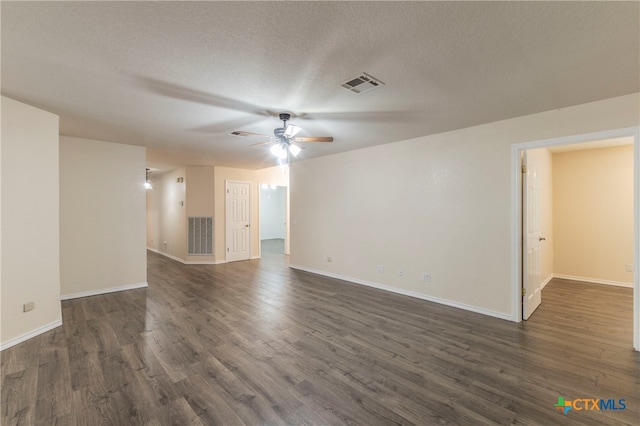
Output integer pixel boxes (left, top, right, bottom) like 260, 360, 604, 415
291, 94, 640, 319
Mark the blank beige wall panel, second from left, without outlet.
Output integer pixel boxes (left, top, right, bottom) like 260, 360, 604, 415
60, 136, 147, 299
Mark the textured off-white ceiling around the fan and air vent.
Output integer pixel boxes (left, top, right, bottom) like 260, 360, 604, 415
1, 1, 640, 169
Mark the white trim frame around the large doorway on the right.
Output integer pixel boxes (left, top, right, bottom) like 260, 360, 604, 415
511, 127, 640, 351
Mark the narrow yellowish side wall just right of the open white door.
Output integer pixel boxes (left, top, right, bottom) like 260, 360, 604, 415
527, 148, 555, 286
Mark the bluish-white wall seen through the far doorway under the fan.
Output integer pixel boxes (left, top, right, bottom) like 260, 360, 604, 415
260, 184, 287, 240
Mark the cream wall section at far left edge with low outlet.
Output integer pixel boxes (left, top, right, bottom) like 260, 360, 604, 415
0, 97, 62, 349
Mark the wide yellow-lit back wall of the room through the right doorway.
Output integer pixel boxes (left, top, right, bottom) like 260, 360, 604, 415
553, 145, 634, 287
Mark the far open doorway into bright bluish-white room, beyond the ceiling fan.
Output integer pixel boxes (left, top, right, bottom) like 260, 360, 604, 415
260, 183, 288, 255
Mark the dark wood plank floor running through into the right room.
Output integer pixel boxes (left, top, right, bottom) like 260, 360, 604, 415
1, 251, 640, 425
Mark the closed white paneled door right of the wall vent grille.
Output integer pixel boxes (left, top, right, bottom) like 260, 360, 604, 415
226, 180, 251, 262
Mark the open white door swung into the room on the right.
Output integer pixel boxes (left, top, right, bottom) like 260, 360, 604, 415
522, 151, 544, 320
